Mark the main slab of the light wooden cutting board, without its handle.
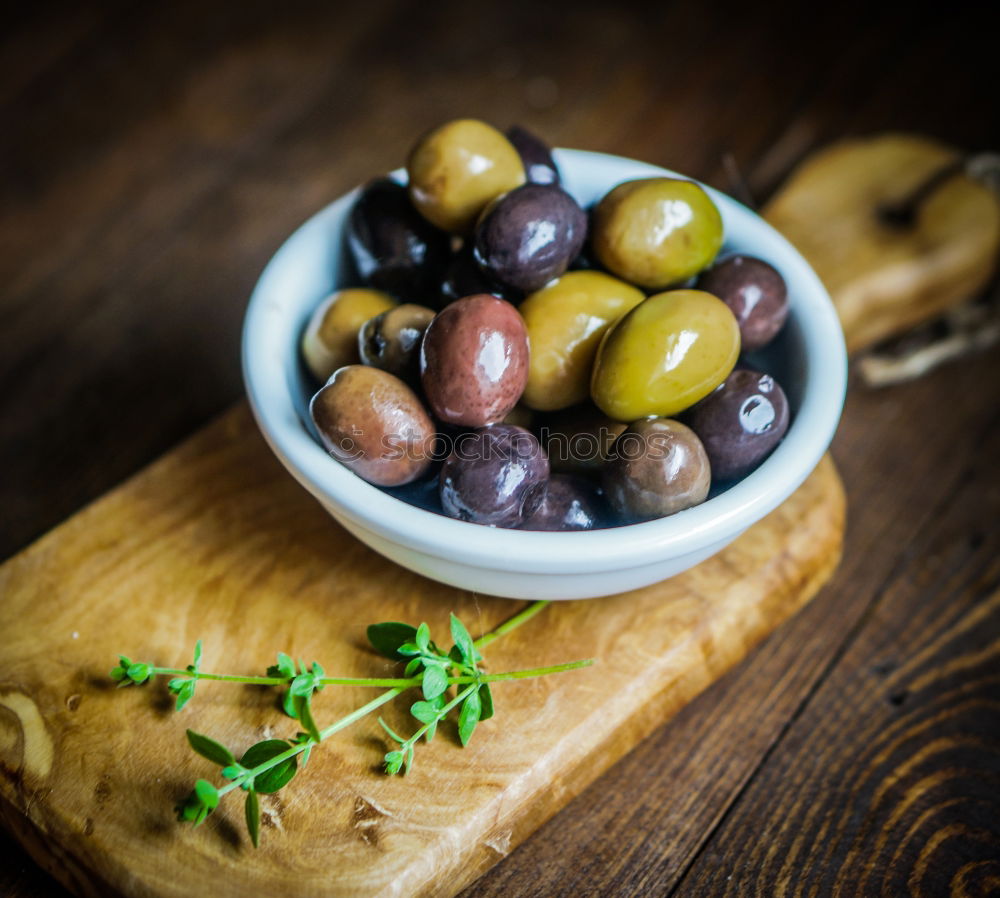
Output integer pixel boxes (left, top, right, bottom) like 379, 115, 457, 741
0, 405, 844, 898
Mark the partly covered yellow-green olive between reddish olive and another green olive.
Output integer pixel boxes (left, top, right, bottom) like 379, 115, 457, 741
520, 271, 645, 411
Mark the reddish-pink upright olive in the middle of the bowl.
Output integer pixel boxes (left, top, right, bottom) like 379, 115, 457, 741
420, 293, 528, 427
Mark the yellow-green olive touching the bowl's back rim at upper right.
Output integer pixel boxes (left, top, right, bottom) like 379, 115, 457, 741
591, 178, 722, 290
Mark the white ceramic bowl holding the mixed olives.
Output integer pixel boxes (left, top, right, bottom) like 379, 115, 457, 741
243, 150, 847, 599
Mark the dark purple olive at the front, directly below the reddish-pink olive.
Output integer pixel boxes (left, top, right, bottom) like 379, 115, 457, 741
440, 424, 549, 527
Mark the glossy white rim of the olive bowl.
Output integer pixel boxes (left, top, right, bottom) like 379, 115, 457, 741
242, 148, 847, 574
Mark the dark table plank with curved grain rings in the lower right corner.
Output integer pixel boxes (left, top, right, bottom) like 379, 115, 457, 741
678, 362, 1000, 898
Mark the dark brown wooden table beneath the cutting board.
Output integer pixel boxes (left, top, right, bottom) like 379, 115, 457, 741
0, 0, 1000, 898
